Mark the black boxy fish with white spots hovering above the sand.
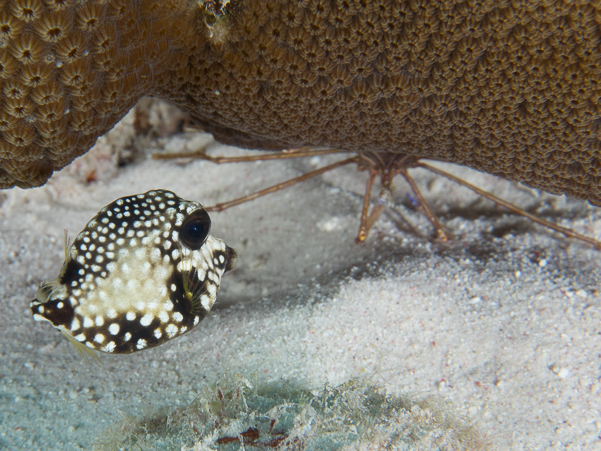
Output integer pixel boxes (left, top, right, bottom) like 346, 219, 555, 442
30, 190, 236, 354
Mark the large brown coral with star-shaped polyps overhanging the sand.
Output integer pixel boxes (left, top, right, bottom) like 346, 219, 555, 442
0, 0, 601, 205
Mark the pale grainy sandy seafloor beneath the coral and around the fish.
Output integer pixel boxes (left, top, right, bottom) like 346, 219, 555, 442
0, 103, 601, 450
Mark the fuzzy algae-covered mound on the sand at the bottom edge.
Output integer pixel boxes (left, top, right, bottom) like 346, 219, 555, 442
96, 375, 486, 451
